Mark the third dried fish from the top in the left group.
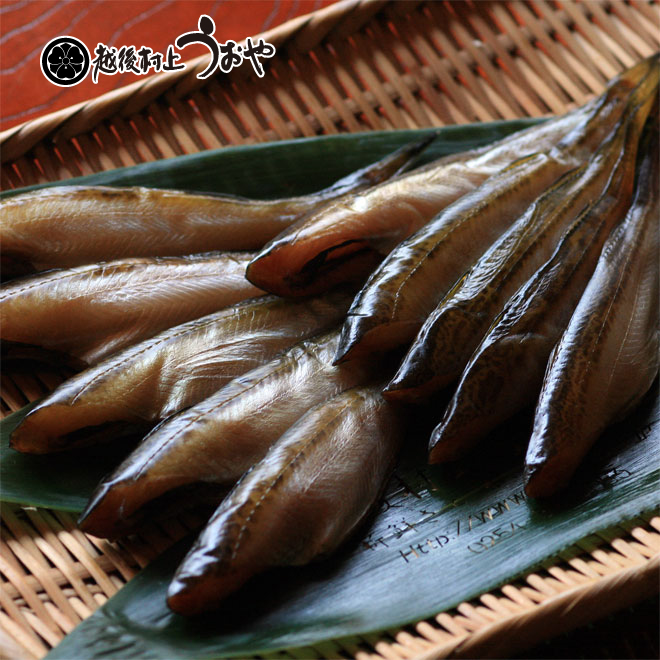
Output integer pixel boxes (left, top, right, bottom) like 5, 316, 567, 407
11, 290, 352, 453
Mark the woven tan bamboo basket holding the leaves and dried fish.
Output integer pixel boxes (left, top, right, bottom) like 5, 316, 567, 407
0, 0, 660, 660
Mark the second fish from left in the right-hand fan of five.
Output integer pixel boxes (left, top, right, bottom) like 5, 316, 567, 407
336, 60, 652, 360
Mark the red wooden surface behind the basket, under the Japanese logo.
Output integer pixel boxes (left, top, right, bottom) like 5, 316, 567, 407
0, 0, 334, 130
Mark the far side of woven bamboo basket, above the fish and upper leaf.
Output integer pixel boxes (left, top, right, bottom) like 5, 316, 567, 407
0, 0, 660, 183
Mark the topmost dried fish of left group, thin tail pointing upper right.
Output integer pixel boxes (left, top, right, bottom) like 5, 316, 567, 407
0, 138, 430, 278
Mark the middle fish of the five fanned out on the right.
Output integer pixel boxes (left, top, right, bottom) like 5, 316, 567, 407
385, 73, 658, 401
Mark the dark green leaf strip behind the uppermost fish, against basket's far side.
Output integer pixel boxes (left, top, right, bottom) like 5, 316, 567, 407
2, 119, 539, 199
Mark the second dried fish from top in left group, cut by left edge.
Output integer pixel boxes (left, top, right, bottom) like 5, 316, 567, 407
0, 252, 263, 365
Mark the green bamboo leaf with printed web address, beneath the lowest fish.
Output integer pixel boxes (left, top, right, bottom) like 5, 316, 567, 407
48, 387, 660, 660
